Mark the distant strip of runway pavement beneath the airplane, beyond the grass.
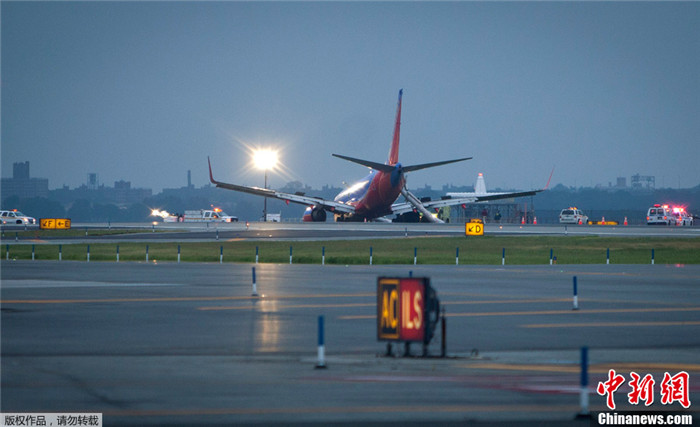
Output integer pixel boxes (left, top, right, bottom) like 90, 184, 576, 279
3, 222, 700, 244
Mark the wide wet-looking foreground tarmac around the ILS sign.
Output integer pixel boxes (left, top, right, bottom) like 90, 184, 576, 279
1, 261, 700, 425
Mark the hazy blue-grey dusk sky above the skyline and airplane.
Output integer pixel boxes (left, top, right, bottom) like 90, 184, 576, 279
0, 1, 700, 192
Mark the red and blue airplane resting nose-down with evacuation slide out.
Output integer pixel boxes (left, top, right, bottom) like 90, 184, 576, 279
207, 89, 543, 223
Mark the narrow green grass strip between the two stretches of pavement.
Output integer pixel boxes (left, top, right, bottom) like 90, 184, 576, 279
2, 236, 700, 265
